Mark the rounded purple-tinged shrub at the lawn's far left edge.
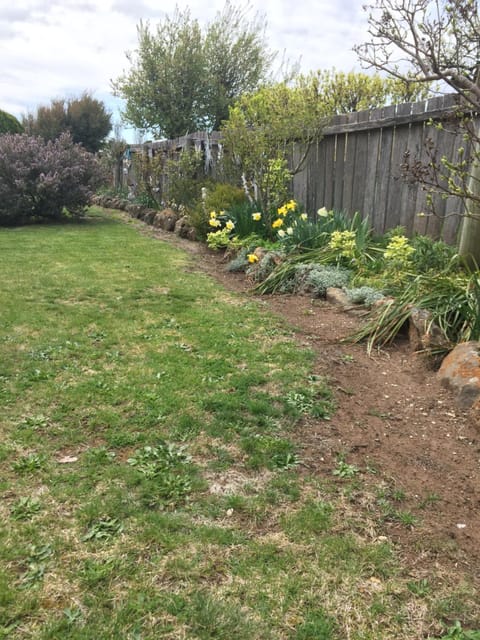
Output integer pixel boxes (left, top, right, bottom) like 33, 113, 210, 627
0, 134, 102, 225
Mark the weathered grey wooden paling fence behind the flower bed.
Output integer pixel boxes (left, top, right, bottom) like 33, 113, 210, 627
132, 95, 468, 244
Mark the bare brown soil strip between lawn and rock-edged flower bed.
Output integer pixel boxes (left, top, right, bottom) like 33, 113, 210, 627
133, 223, 480, 587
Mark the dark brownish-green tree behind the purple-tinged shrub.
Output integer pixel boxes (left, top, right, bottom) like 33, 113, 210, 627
23, 92, 112, 153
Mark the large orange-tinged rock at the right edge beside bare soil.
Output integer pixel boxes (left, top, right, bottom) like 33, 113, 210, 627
438, 342, 480, 410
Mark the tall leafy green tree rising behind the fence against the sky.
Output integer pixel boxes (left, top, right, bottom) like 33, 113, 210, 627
112, 2, 273, 138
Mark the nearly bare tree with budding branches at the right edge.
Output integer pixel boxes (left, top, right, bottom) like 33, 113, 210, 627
355, 0, 480, 264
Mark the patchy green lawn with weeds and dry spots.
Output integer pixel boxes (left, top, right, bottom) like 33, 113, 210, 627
0, 210, 478, 640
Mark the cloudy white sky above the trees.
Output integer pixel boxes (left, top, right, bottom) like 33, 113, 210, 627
0, 0, 367, 142
